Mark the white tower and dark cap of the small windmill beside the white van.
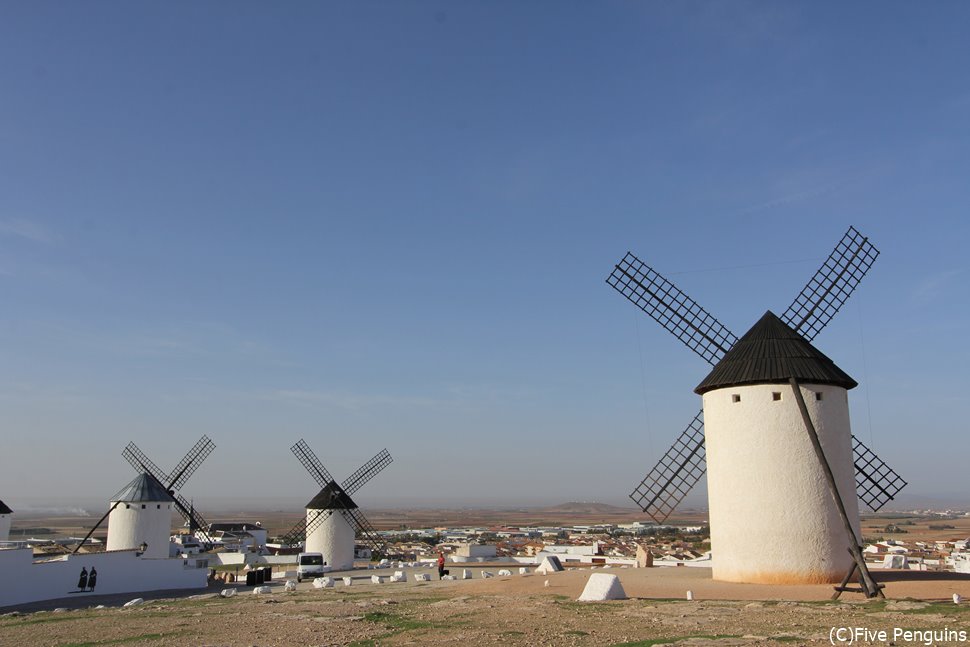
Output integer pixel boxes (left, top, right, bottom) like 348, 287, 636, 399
305, 483, 357, 571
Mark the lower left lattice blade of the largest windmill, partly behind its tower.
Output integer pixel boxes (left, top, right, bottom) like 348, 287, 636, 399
630, 411, 707, 523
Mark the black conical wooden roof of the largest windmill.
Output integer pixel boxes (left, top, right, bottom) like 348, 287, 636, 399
694, 310, 858, 395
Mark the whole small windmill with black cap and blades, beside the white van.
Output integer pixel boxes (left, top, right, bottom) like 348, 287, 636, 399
284, 439, 394, 571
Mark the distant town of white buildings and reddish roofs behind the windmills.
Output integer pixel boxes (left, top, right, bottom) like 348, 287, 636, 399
11, 509, 970, 573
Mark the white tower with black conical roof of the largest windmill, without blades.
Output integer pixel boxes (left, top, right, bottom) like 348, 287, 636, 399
696, 312, 860, 584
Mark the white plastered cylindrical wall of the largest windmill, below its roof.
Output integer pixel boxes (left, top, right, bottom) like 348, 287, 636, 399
704, 384, 859, 584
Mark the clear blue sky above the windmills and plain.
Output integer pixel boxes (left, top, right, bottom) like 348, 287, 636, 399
0, 2, 970, 511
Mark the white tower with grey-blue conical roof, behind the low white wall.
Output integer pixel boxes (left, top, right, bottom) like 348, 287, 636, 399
105, 474, 173, 559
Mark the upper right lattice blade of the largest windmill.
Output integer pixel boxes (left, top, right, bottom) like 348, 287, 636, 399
781, 227, 879, 341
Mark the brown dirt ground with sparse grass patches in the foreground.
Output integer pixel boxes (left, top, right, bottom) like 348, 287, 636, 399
0, 568, 970, 647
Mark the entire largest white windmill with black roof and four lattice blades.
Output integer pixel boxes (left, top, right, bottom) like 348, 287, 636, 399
607, 227, 906, 595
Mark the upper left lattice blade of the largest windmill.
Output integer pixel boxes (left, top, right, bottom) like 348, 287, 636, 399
606, 252, 738, 364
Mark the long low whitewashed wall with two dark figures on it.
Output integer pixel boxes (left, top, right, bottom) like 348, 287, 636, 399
0, 548, 208, 607
